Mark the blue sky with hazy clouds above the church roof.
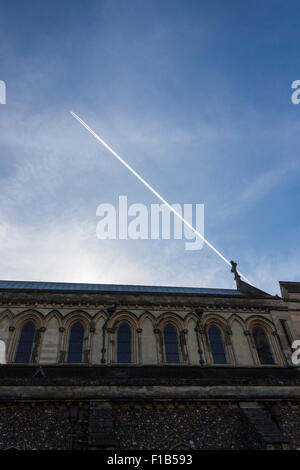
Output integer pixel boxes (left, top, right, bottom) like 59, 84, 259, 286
0, 0, 300, 293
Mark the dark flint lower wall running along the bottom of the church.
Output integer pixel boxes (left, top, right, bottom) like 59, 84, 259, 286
0, 400, 300, 450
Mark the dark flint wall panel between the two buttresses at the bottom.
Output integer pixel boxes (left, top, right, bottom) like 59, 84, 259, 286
113, 402, 263, 450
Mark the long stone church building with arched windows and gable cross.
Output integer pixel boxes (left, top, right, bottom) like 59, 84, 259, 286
0, 263, 300, 450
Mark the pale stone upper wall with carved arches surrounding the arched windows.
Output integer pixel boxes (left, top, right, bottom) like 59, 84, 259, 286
0, 290, 291, 367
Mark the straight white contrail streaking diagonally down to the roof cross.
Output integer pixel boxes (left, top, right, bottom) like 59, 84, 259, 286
70, 111, 251, 284
